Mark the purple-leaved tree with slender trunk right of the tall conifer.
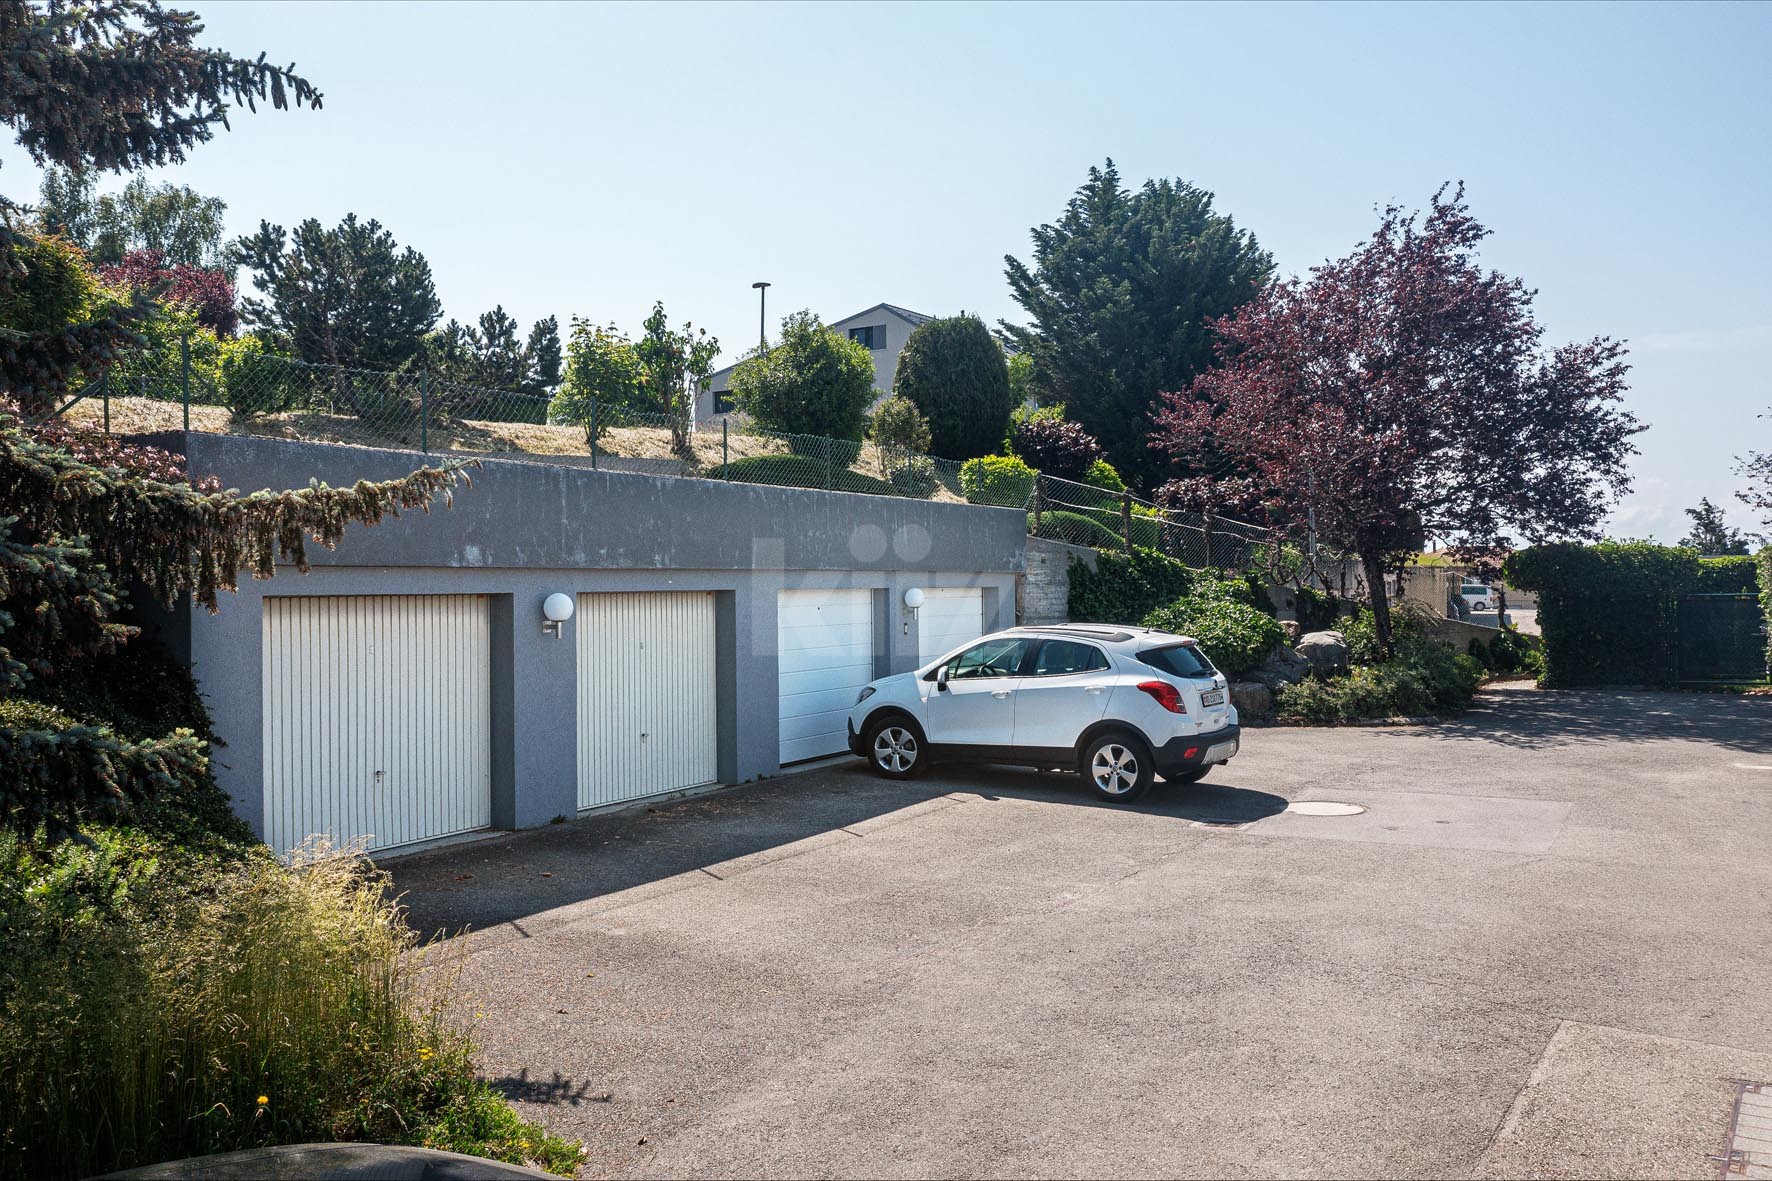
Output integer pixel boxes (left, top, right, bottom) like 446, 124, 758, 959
1150, 184, 1643, 651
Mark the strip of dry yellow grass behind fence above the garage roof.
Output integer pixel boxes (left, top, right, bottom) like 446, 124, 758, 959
67, 397, 959, 500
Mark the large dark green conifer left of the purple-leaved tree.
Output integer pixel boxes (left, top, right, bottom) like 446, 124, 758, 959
1003, 160, 1274, 486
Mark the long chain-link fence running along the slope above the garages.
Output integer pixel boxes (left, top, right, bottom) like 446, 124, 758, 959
60, 340, 1271, 569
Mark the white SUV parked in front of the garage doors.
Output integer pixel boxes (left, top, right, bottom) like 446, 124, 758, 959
849, 624, 1240, 802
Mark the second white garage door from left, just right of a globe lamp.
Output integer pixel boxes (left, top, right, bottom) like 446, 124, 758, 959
574, 591, 719, 809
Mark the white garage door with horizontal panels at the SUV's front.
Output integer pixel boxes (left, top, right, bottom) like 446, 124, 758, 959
776, 591, 874, 763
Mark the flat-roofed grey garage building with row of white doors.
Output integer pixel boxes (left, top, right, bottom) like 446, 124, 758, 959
144, 433, 1026, 849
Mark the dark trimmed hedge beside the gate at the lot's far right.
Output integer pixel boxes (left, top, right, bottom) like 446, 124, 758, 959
1503, 541, 1694, 688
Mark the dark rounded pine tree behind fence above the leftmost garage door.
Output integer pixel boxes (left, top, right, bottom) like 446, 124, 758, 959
234, 213, 443, 369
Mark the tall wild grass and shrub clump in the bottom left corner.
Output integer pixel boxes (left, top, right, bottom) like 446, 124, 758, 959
0, 828, 579, 1177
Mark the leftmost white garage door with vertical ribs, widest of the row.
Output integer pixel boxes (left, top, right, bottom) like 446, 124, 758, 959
264, 594, 493, 853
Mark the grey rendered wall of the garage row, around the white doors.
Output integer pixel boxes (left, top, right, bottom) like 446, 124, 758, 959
140, 433, 1026, 828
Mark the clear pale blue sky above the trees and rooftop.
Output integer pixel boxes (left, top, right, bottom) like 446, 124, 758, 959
0, 0, 1772, 541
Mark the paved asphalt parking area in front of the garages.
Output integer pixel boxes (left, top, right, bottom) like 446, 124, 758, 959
395, 688, 1772, 1177
